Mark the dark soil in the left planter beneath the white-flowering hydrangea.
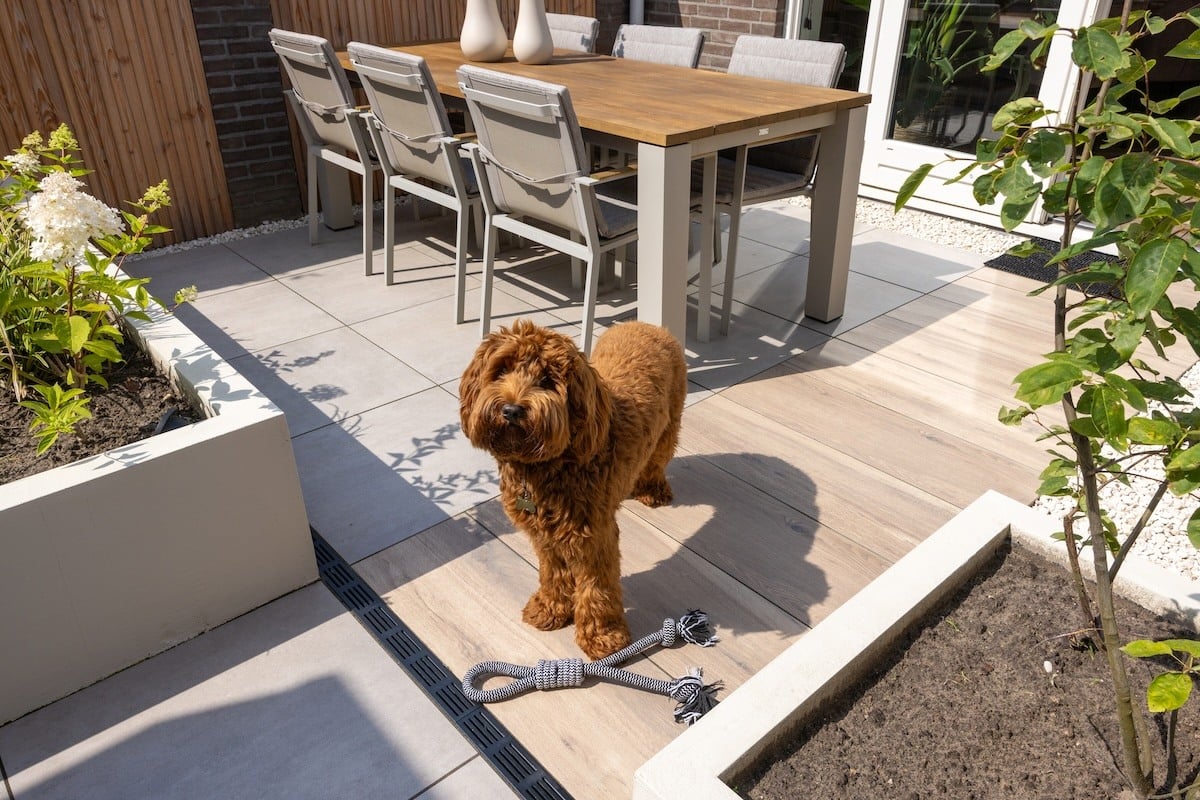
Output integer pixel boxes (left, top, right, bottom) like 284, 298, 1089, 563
0, 344, 192, 483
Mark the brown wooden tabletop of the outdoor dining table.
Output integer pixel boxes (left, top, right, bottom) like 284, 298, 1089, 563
338, 41, 871, 146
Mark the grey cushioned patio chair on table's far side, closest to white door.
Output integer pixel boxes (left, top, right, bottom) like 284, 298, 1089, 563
692, 36, 846, 342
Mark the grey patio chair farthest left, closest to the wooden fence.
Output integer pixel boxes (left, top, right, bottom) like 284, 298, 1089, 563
268, 28, 379, 275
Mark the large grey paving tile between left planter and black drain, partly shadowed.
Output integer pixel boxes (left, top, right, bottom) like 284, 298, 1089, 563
0, 584, 477, 800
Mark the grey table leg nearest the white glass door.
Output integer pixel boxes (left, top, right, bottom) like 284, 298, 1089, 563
804, 107, 866, 323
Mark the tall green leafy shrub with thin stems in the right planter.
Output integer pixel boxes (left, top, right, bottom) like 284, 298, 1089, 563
896, 0, 1200, 798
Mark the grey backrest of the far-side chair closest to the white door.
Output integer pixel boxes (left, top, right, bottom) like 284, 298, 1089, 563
728, 36, 846, 180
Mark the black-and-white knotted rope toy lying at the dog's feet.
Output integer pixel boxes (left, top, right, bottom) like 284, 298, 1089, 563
462, 609, 722, 724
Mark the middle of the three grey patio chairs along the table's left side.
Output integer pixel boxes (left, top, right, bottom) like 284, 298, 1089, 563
347, 42, 484, 324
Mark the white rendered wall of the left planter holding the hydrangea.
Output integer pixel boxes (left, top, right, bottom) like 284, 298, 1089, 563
0, 291, 317, 724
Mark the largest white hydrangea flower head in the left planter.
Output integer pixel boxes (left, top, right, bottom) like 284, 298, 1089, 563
20, 172, 122, 264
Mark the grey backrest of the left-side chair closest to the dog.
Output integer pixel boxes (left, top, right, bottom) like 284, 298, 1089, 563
458, 64, 594, 234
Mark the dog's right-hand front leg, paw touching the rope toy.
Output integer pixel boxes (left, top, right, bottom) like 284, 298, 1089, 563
574, 519, 630, 661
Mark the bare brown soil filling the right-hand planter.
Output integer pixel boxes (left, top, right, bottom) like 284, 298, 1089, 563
733, 547, 1200, 800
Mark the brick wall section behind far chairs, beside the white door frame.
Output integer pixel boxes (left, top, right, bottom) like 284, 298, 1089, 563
646, 0, 786, 70
